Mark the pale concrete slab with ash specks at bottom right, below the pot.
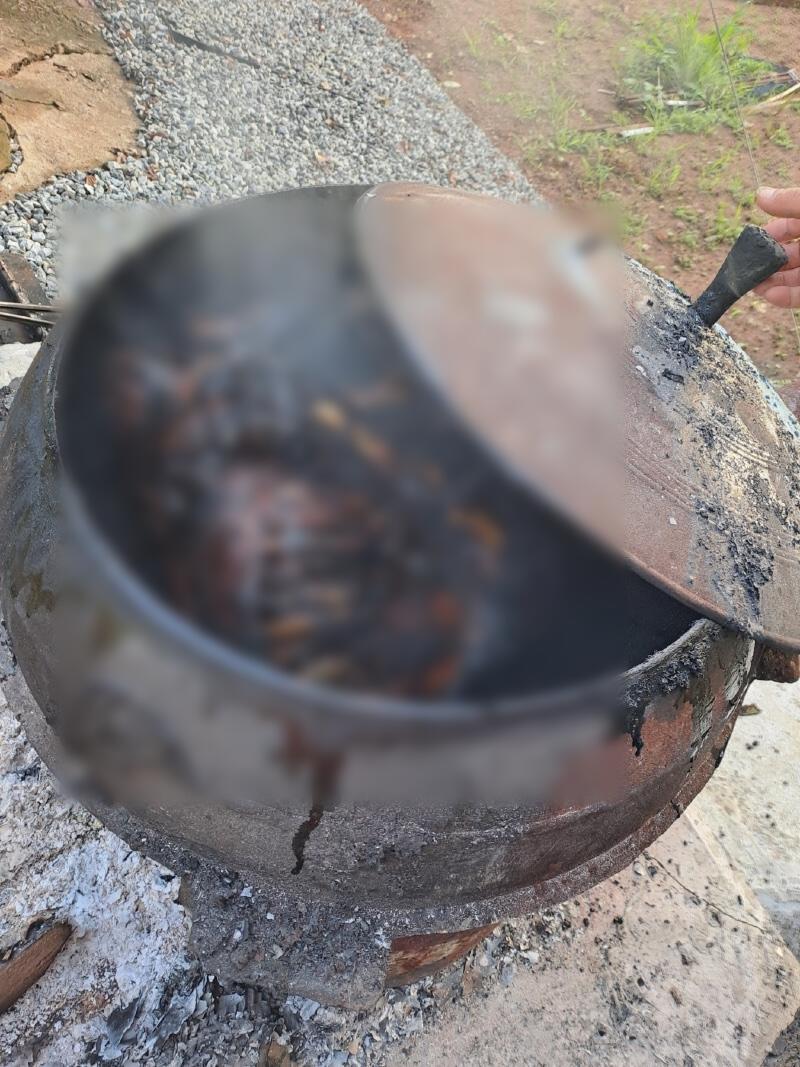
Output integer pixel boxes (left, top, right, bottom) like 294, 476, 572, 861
385, 813, 800, 1067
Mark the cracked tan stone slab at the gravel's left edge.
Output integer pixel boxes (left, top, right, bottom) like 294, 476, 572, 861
0, 0, 137, 202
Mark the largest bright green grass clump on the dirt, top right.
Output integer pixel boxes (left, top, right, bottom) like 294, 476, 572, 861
620, 11, 766, 132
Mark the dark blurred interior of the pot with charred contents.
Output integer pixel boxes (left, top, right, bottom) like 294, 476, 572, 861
57, 196, 695, 699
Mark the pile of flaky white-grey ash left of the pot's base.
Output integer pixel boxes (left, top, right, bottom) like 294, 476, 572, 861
0, 665, 190, 1065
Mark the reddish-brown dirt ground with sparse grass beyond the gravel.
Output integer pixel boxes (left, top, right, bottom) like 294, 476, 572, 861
365, 0, 800, 410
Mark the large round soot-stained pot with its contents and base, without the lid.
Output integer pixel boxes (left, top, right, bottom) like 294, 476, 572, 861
0, 189, 800, 1006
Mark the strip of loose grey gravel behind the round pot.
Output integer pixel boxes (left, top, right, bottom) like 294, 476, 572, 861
0, 0, 534, 293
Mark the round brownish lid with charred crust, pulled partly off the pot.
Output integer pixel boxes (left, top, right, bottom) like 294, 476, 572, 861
356, 184, 800, 650
